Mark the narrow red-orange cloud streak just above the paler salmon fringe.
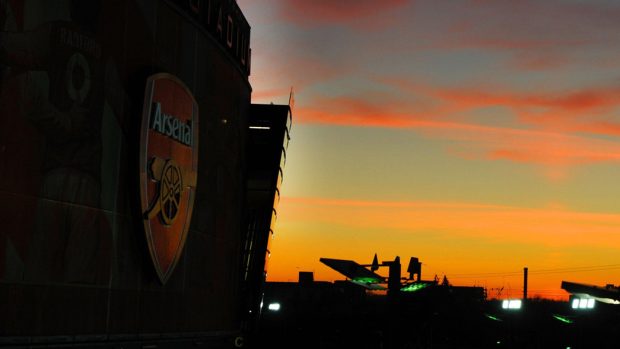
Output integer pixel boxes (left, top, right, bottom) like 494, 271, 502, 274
298, 79, 620, 136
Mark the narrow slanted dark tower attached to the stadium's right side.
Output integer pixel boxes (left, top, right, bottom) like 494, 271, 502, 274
242, 104, 292, 329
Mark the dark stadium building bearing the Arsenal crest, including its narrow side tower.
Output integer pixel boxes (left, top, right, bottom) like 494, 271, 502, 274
0, 0, 291, 348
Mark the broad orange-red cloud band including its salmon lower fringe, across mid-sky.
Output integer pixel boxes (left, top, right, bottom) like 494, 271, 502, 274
295, 86, 620, 180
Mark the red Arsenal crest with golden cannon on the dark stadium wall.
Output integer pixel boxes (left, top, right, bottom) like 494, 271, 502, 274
140, 73, 198, 284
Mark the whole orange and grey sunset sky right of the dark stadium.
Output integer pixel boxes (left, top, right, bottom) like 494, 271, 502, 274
238, 0, 620, 298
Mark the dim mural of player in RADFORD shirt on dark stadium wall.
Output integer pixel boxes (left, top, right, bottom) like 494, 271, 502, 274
0, 0, 120, 284
